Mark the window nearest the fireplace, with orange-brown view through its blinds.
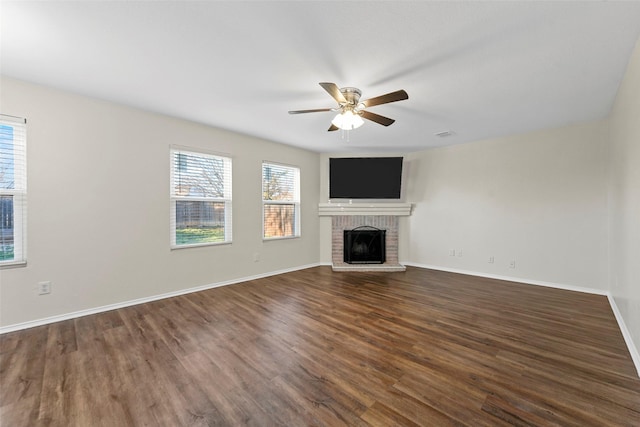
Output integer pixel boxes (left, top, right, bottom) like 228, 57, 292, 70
262, 162, 300, 239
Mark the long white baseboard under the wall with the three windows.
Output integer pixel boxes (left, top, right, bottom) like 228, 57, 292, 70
0, 263, 320, 335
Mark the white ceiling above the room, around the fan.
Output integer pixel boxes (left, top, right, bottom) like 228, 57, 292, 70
0, 1, 640, 152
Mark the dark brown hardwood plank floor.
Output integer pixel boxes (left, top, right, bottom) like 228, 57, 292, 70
0, 267, 640, 427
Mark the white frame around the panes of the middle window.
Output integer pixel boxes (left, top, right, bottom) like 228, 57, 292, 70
169, 145, 233, 250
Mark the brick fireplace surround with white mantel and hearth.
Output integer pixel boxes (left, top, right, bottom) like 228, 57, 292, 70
319, 203, 411, 271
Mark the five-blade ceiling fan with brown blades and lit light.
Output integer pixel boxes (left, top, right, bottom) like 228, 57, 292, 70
289, 82, 409, 132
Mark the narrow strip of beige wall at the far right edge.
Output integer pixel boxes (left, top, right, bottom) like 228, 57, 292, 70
609, 36, 640, 358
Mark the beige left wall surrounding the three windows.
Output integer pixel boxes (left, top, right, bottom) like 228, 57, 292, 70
0, 79, 320, 327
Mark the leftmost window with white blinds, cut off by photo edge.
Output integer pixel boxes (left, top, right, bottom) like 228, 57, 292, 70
0, 115, 27, 266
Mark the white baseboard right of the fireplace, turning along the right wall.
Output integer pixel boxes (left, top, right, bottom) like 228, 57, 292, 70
402, 262, 640, 377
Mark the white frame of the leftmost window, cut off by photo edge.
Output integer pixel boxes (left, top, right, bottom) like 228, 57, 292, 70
0, 114, 27, 269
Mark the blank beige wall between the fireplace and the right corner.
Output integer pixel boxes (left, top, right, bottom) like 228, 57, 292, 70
407, 122, 608, 292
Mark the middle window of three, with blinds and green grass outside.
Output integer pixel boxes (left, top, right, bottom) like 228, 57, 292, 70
171, 147, 231, 248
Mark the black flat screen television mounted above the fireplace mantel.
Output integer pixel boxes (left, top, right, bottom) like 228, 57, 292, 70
329, 157, 402, 199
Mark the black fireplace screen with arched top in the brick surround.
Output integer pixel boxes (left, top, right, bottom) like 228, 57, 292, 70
344, 226, 386, 264
